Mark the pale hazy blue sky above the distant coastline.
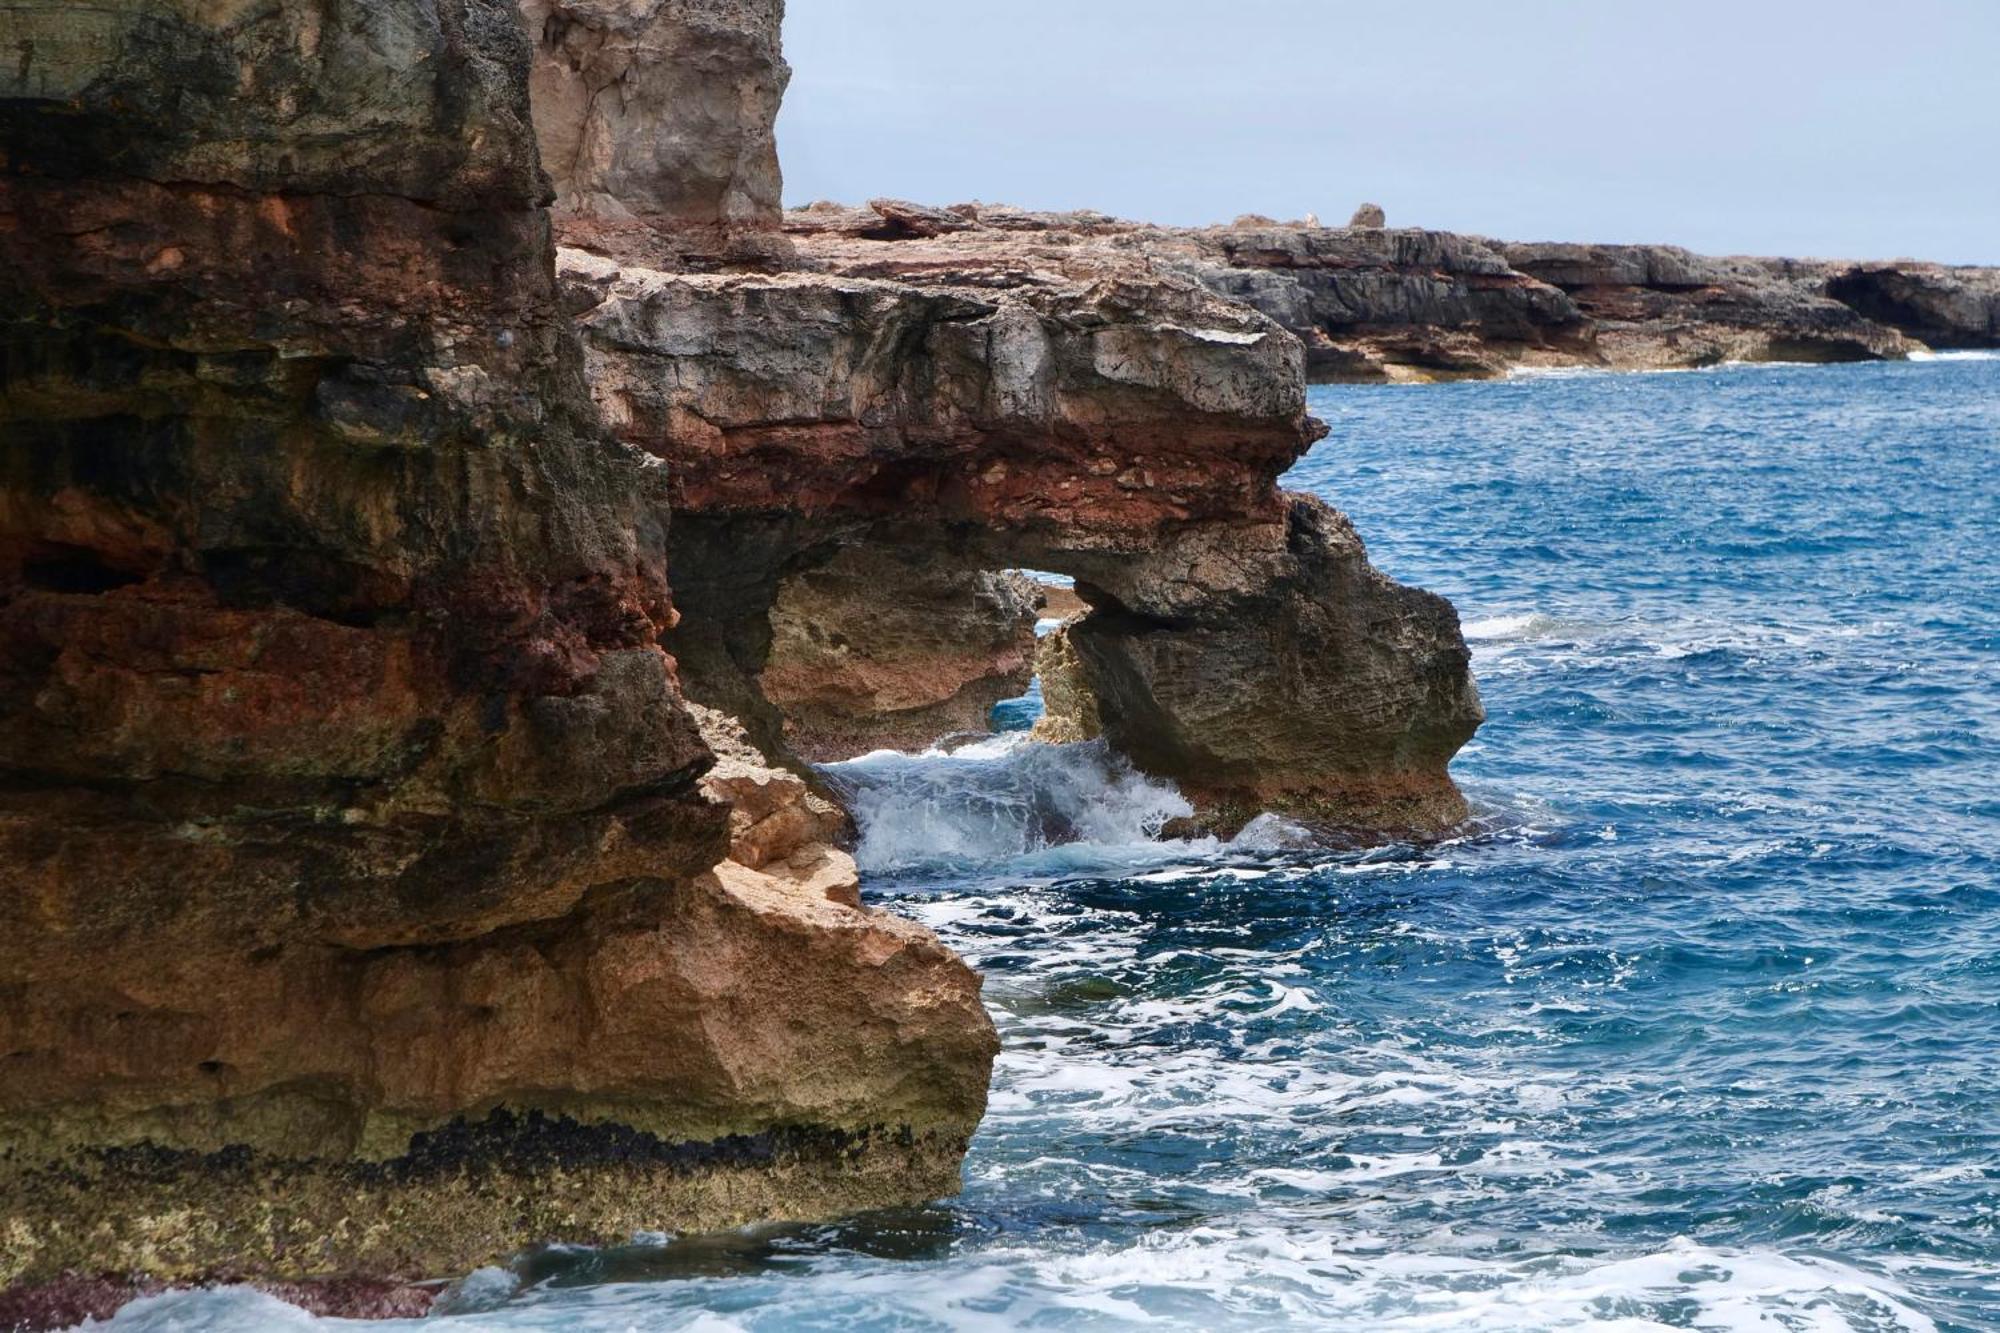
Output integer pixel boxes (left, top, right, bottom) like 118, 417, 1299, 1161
778, 0, 2000, 262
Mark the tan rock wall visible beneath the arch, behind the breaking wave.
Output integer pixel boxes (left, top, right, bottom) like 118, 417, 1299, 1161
758, 548, 1042, 763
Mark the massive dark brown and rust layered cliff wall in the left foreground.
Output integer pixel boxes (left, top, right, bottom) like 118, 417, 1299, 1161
0, 0, 994, 1295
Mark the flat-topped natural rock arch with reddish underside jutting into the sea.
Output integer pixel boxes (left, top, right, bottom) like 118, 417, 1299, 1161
560, 200, 1480, 831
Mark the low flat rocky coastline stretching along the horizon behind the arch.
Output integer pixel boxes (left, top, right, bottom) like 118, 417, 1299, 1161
786, 200, 2000, 382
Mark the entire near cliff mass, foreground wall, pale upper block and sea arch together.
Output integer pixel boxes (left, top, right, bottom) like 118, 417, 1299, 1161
0, 0, 1504, 1325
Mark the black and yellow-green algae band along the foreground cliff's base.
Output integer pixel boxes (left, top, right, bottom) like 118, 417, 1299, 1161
0, 1111, 966, 1304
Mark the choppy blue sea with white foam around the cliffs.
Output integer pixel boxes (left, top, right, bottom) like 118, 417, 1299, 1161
90, 358, 2000, 1333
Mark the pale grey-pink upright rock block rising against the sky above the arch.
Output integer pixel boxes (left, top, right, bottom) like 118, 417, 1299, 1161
520, 0, 792, 268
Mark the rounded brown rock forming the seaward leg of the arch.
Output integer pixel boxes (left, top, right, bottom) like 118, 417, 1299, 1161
1072, 496, 1486, 835
